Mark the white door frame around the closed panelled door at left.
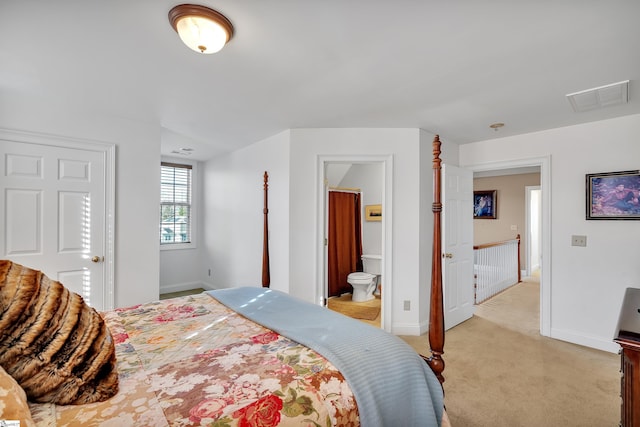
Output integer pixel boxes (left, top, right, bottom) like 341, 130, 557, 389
0, 128, 116, 310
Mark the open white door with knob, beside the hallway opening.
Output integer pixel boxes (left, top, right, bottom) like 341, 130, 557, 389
442, 164, 474, 330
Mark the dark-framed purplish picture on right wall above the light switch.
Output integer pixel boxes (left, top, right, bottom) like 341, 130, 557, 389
586, 170, 640, 219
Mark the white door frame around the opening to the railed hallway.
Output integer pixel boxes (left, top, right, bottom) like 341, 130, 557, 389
463, 156, 552, 337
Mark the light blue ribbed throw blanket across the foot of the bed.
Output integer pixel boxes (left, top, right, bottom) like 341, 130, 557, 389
207, 287, 443, 427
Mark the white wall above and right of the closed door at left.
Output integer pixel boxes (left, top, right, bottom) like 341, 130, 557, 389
0, 92, 160, 307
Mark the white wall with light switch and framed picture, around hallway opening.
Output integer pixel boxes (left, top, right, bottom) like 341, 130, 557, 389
460, 115, 640, 351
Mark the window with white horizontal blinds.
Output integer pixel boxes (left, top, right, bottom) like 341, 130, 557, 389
160, 162, 193, 246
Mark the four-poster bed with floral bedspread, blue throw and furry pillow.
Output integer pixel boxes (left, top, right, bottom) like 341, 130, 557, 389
0, 136, 448, 427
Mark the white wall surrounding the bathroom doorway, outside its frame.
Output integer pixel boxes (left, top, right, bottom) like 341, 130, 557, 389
290, 129, 430, 334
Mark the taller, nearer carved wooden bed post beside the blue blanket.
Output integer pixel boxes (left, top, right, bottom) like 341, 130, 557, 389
425, 135, 444, 384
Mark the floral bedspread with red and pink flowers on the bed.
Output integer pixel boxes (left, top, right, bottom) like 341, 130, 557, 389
30, 294, 359, 427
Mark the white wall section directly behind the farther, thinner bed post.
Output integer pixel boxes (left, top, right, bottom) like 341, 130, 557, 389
201, 131, 295, 292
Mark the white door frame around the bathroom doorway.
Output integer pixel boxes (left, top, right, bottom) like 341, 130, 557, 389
316, 155, 393, 332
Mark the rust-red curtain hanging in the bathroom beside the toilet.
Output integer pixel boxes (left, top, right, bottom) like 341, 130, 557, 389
327, 191, 362, 297
